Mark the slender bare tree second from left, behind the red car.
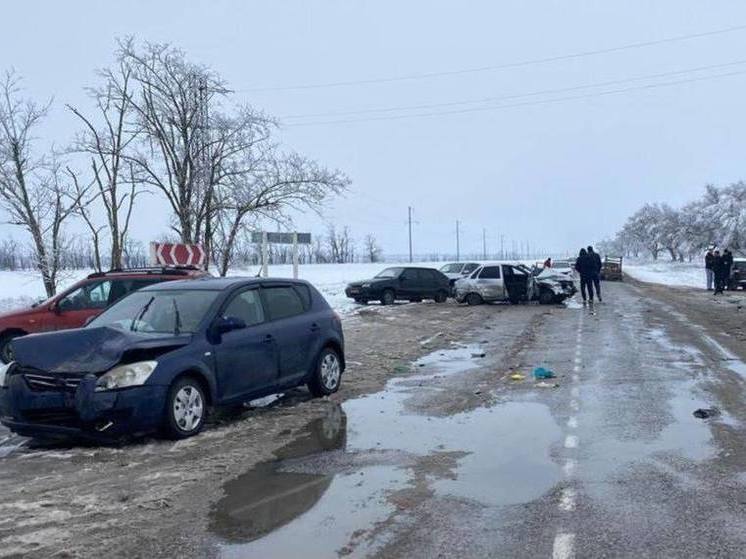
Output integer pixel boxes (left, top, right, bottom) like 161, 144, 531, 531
67, 60, 141, 268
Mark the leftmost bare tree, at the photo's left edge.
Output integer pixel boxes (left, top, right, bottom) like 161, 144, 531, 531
0, 72, 83, 297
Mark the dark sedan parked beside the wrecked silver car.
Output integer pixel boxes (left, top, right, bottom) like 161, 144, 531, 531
345, 266, 451, 305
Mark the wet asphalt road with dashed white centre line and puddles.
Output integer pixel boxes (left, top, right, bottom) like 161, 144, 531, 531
210, 284, 746, 559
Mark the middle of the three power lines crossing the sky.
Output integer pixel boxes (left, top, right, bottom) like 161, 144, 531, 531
280, 59, 746, 120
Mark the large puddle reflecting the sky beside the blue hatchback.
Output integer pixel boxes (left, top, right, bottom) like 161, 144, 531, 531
210, 346, 562, 558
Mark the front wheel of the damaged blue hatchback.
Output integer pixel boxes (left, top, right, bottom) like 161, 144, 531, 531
164, 377, 207, 439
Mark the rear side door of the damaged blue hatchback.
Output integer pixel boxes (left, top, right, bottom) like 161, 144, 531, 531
261, 284, 320, 385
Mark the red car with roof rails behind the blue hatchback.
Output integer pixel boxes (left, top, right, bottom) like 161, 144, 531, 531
0, 267, 209, 363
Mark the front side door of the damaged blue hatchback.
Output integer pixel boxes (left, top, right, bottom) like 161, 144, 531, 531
214, 288, 279, 400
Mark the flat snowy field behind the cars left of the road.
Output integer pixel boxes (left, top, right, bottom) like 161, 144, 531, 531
0, 262, 454, 313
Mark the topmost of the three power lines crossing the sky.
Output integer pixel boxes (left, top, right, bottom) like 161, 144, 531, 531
237, 25, 746, 92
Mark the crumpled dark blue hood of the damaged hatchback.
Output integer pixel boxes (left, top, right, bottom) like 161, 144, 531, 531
13, 326, 192, 373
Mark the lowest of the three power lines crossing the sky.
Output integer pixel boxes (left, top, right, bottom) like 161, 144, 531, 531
286, 70, 746, 128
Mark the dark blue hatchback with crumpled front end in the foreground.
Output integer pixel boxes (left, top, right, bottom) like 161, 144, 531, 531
0, 278, 345, 439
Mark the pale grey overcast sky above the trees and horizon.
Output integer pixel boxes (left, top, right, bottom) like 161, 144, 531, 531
0, 0, 746, 260
